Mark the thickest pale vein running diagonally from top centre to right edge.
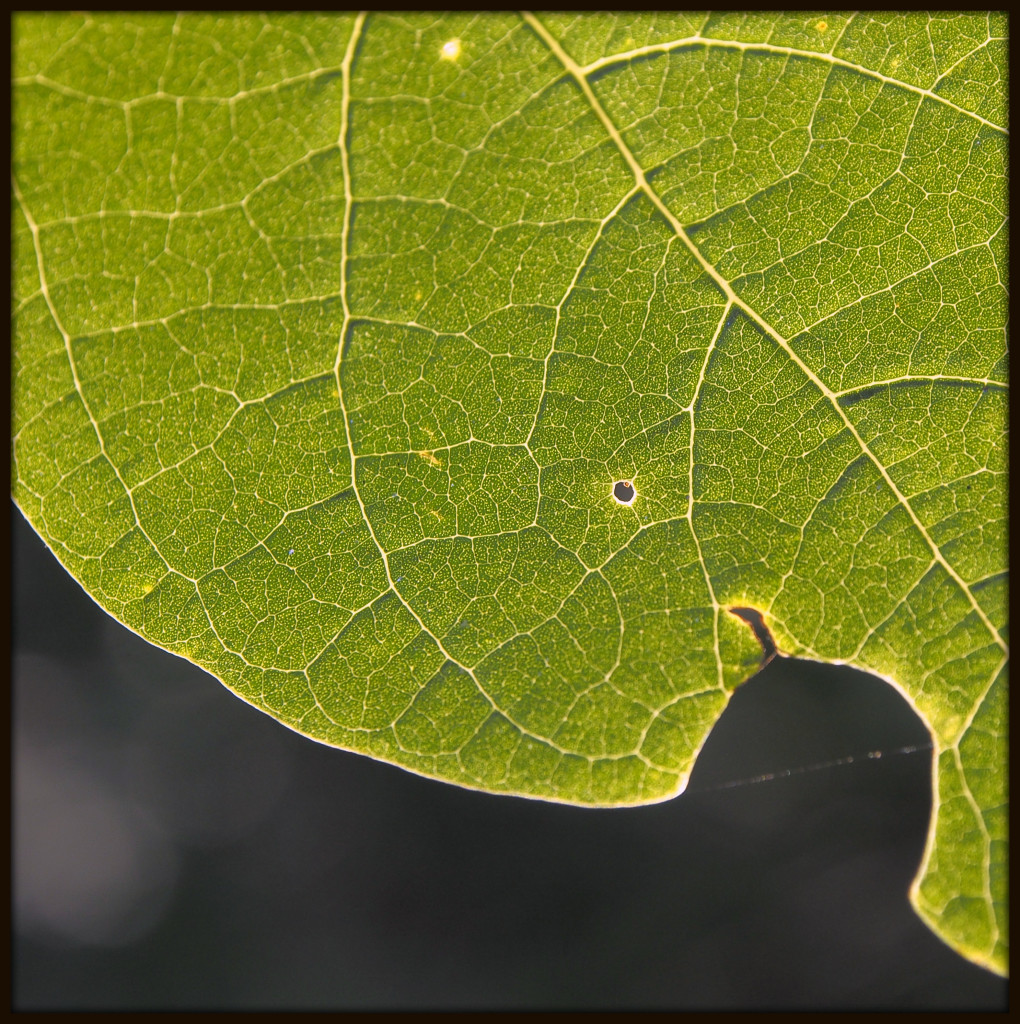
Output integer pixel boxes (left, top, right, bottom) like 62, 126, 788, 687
521, 11, 1007, 652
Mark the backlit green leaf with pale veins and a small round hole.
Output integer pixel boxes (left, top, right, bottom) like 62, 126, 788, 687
12, 13, 1007, 972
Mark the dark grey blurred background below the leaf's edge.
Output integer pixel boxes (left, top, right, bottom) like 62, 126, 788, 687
11, 509, 1007, 1011
